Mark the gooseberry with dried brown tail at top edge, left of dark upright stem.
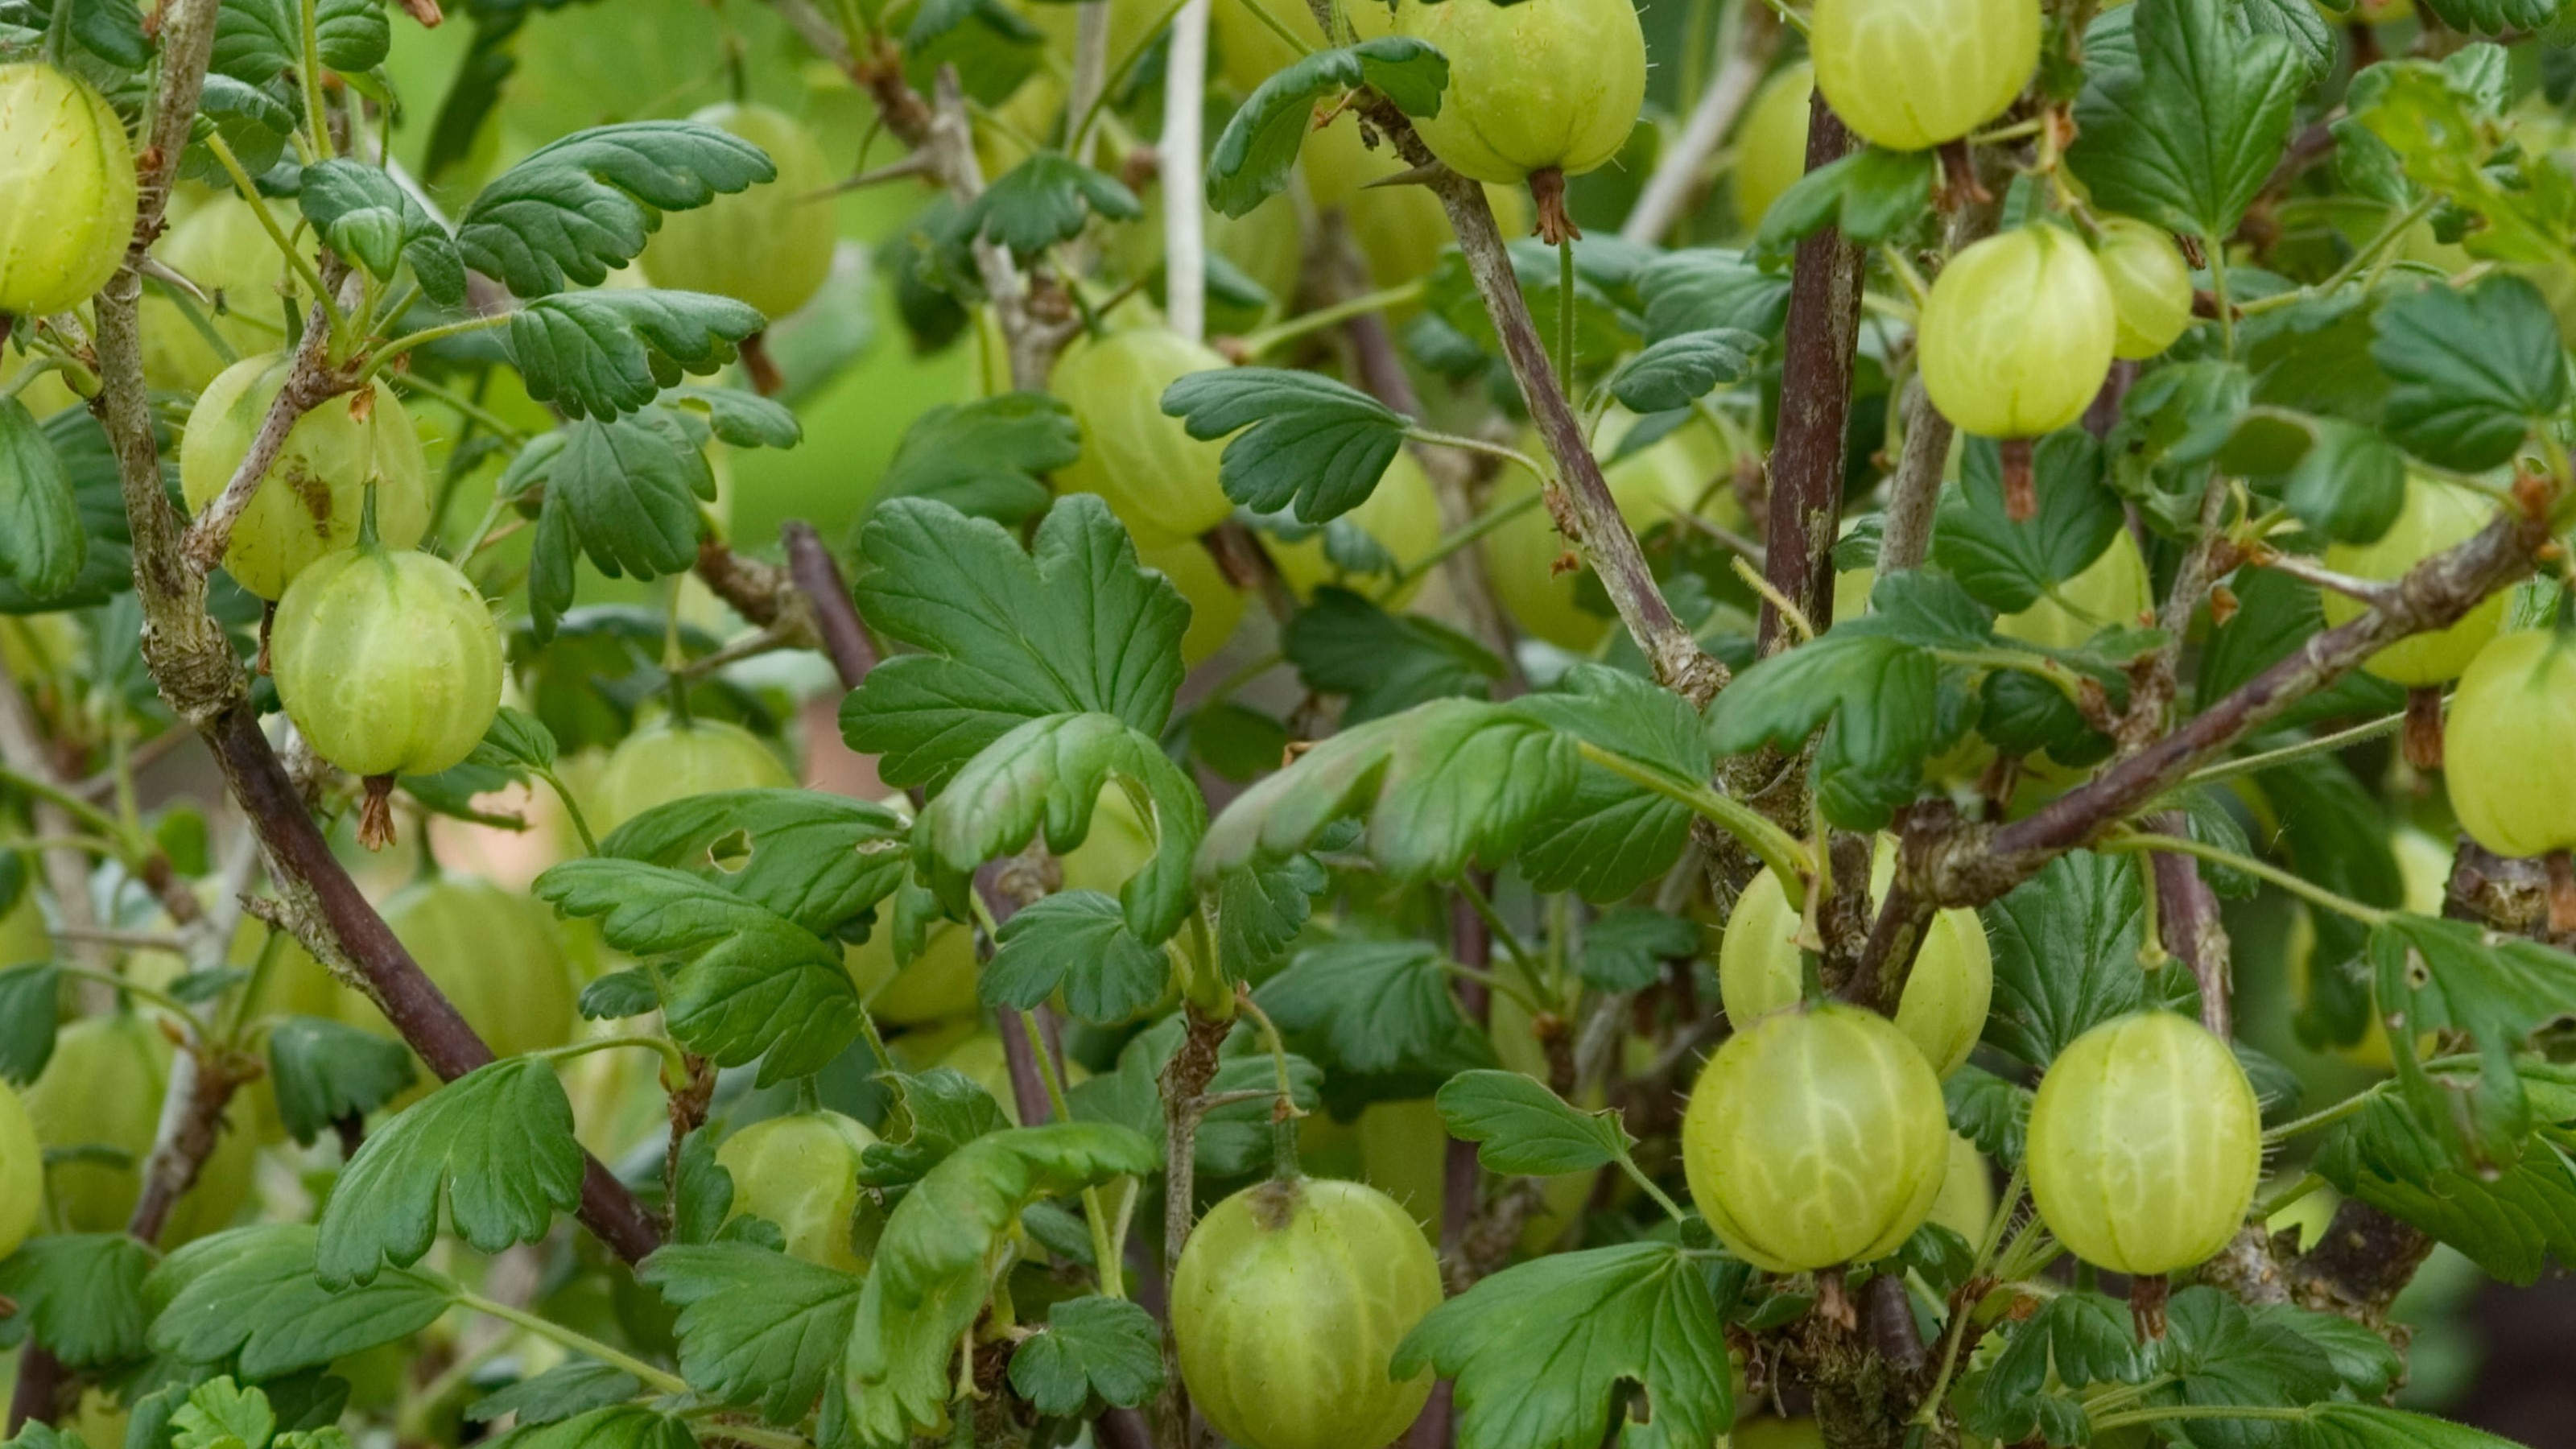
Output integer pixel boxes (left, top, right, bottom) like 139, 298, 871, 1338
1396, 0, 1646, 245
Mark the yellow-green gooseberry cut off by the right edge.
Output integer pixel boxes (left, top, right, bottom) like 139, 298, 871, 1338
2442, 629, 2576, 856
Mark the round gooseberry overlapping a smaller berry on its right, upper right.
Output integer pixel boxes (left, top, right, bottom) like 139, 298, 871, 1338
1914, 225, 2120, 438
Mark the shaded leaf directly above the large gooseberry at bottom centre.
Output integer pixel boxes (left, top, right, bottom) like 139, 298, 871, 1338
1254, 941, 1468, 1072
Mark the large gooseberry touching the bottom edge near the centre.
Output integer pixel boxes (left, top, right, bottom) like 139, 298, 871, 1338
1172, 1175, 1452, 1449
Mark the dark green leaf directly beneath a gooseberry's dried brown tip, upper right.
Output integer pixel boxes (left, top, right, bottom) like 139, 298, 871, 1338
1932, 428, 2128, 613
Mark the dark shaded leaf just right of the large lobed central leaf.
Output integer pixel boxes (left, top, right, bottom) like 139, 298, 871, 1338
1280, 583, 1509, 727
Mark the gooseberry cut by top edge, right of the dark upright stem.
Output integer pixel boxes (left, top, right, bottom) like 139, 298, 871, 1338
1806, 0, 2040, 152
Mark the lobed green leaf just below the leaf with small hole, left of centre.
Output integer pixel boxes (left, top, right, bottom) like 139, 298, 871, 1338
533, 856, 861, 1085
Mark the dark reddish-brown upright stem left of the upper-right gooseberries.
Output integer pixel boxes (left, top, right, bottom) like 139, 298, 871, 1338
1760, 90, 1863, 655
